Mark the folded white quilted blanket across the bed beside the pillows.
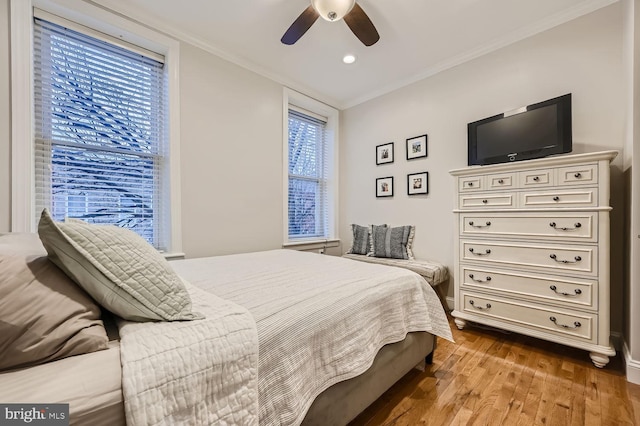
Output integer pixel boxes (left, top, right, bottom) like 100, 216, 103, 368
118, 283, 258, 426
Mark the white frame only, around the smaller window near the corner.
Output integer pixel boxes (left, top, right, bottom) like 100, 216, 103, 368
282, 87, 340, 249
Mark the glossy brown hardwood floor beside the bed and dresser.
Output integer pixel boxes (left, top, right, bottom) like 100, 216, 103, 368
350, 318, 640, 426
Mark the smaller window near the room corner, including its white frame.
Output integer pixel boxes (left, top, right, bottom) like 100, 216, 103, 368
285, 92, 337, 244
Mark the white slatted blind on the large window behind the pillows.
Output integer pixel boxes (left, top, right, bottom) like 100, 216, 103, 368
34, 18, 169, 250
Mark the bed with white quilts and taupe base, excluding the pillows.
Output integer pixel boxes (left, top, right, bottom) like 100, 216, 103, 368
0, 231, 452, 425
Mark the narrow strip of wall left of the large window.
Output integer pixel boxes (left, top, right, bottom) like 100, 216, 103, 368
0, 0, 11, 232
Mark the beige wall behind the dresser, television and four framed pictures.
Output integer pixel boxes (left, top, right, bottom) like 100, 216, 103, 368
340, 4, 626, 331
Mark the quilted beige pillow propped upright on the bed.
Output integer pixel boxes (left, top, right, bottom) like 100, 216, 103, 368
38, 209, 203, 321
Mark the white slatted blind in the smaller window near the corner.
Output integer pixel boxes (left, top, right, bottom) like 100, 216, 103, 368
288, 107, 329, 240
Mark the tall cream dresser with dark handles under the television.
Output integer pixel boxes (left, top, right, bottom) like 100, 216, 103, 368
450, 151, 617, 367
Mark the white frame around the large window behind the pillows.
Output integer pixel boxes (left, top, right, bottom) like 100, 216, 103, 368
10, 0, 184, 257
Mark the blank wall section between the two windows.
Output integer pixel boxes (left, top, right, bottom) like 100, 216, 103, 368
180, 43, 283, 257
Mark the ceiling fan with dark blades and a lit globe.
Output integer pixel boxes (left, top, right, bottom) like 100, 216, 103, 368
280, 0, 380, 46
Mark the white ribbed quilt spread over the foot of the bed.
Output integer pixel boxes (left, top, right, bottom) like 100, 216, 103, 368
172, 250, 452, 425
